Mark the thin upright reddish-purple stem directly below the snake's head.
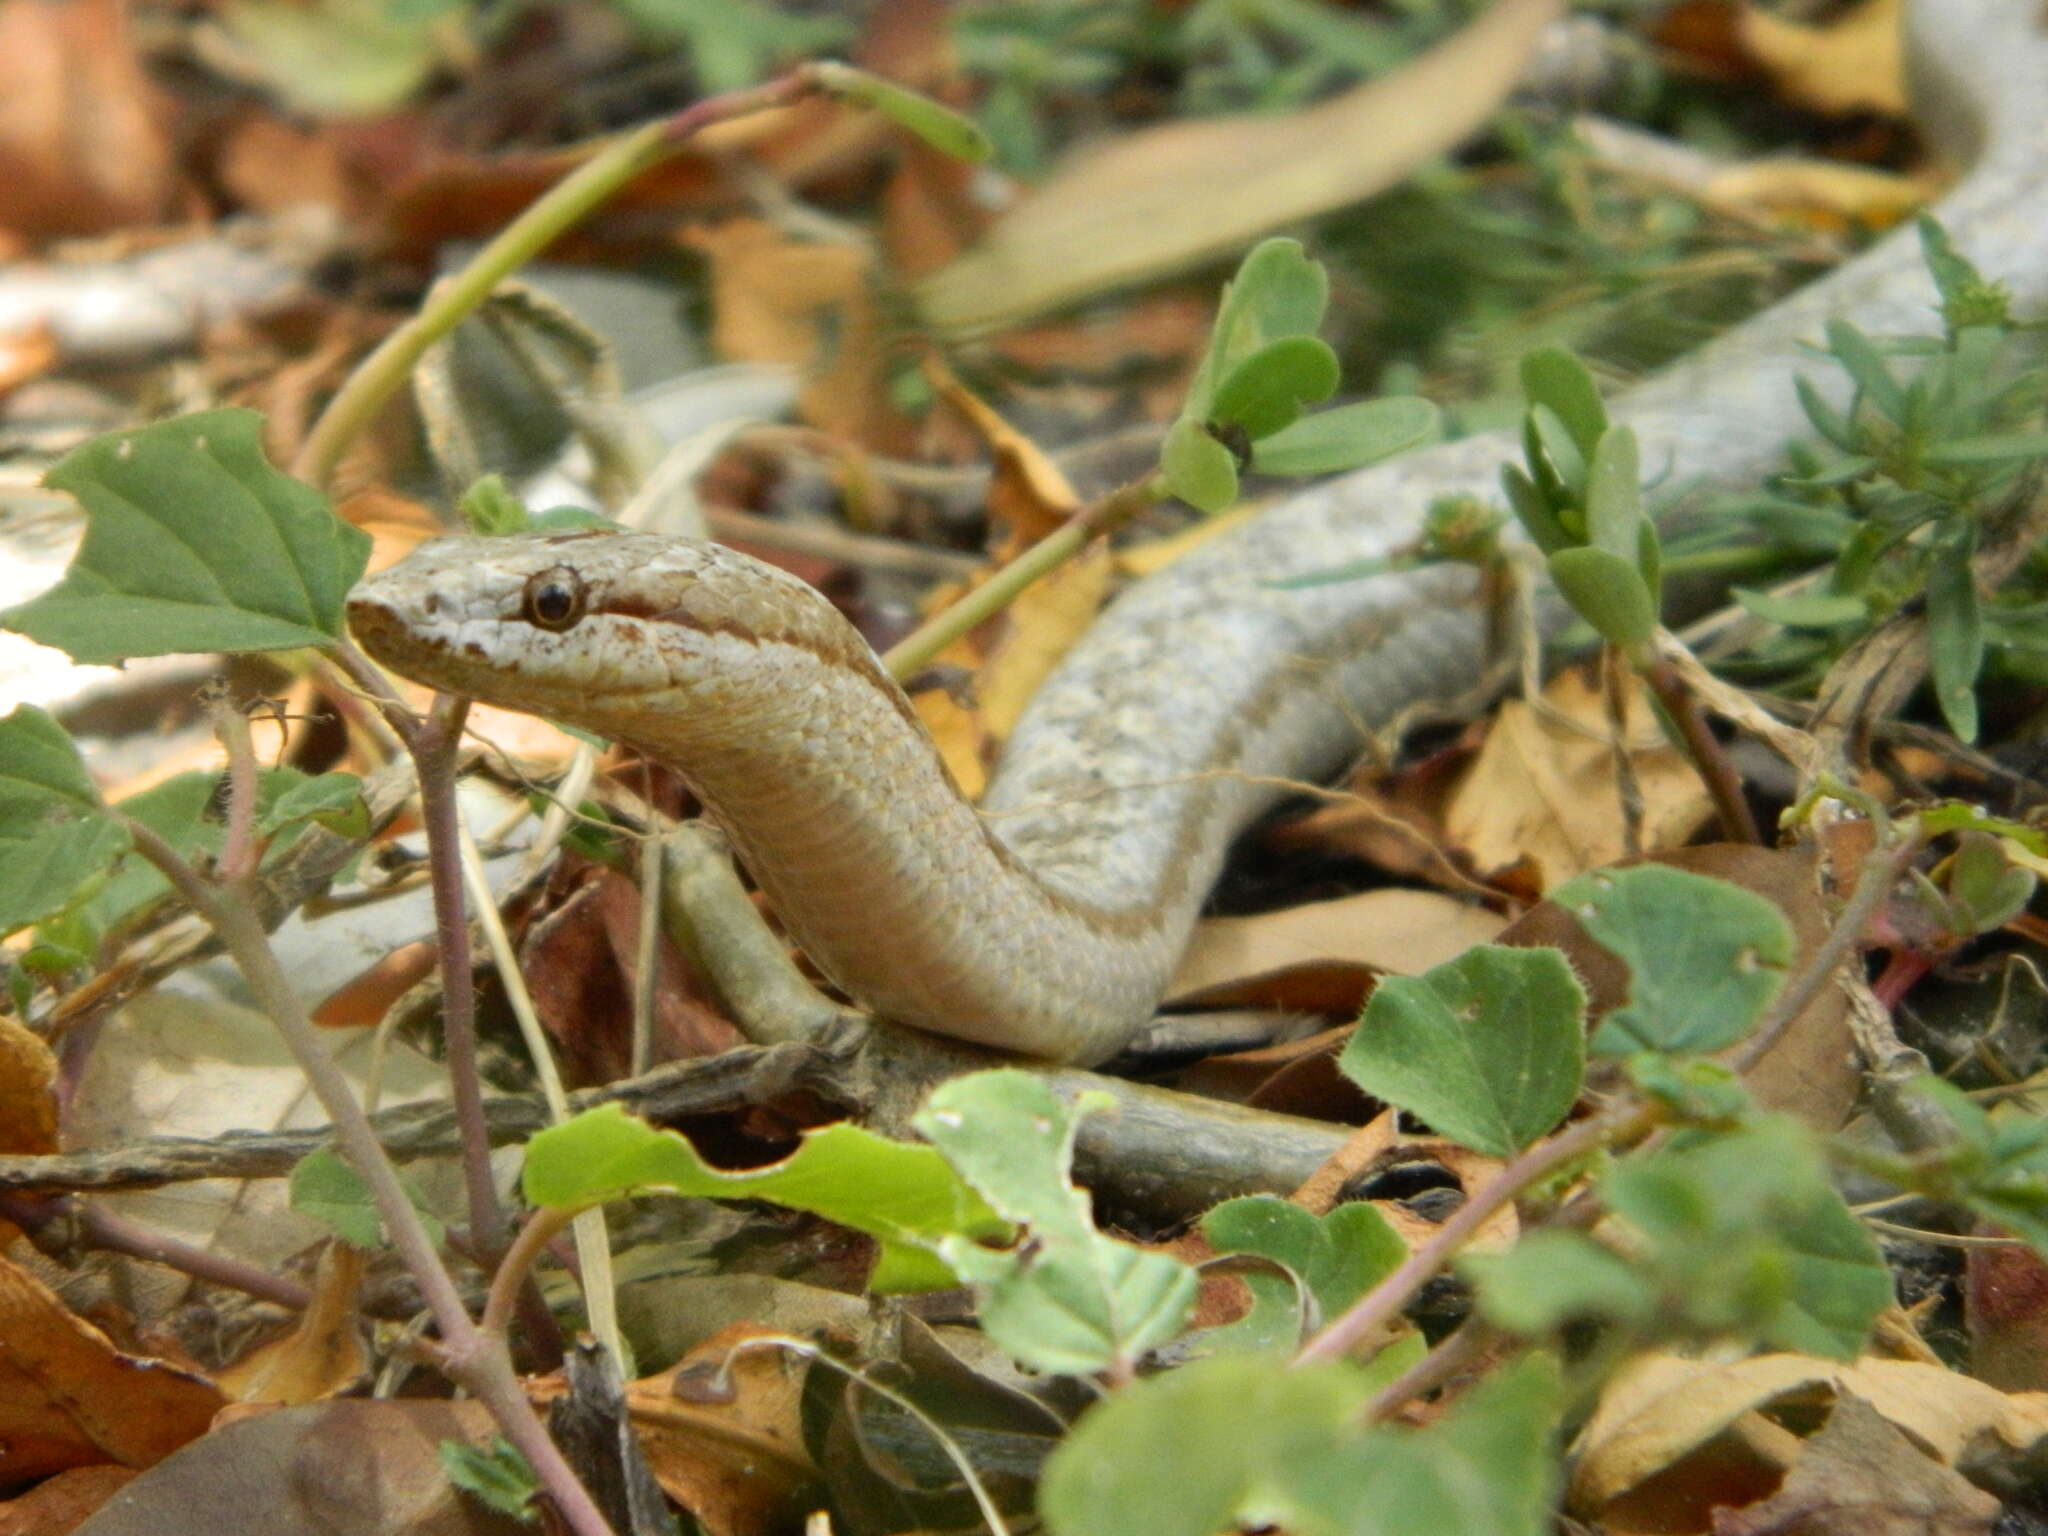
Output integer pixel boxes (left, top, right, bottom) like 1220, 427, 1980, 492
406, 694, 506, 1268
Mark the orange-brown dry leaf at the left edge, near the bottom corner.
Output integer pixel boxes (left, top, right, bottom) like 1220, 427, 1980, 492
0, 1257, 225, 1489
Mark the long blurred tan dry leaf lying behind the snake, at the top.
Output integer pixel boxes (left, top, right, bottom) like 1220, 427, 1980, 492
918, 0, 1563, 332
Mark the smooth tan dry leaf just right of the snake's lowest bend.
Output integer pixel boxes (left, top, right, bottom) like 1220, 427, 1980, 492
1167, 889, 1505, 1004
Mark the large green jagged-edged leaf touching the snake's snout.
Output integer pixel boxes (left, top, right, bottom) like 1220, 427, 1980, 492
0, 410, 371, 662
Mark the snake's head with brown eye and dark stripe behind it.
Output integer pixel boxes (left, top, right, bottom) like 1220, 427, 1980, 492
348, 530, 872, 739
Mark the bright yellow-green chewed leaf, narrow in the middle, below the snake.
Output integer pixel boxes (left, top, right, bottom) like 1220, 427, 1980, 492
522, 1104, 1010, 1292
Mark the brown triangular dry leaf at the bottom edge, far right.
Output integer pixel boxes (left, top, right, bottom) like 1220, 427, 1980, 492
1714, 1393, 2003, 1536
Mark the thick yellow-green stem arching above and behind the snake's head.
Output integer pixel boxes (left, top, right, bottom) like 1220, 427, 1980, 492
291, 68, 817, 485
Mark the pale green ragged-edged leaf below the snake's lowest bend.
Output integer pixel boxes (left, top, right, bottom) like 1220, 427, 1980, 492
911, 1071, 1196, 1374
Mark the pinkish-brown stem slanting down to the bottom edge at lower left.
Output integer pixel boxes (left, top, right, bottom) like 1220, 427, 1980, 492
123, 817, 612, 1536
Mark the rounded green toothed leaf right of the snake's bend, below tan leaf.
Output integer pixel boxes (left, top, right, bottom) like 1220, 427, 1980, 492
1337, 944, 1585, 1157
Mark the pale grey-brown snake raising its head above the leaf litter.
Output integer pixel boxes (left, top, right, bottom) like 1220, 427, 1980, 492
348, 0, 2048, 1065
